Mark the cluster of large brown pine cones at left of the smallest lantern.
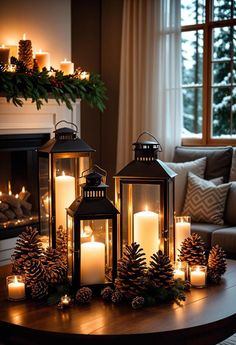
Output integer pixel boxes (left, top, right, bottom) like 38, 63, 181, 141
12, 227, 67, 299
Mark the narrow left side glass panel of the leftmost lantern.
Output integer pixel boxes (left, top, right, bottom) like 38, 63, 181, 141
39, 157, 51, 245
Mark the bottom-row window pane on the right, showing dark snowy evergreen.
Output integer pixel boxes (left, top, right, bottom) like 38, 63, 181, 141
212, 87, 236, 137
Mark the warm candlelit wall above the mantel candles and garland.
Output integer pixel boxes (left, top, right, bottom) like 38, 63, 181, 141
0, 0, 71, 68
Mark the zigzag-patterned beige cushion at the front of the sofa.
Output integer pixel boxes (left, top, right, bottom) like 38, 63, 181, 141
182, 173, 230, 224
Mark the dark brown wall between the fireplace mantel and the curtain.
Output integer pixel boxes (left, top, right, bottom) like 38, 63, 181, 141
71, 0, 123, 199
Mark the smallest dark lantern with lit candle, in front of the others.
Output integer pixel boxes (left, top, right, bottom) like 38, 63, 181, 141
67, 167, 119, 288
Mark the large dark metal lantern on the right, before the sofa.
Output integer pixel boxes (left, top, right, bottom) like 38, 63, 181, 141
115, 132, 176, 263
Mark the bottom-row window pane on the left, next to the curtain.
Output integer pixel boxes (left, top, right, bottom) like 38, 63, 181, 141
182, 87, 202, 138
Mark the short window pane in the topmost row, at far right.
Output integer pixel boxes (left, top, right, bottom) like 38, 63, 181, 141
213, 0, 236, 20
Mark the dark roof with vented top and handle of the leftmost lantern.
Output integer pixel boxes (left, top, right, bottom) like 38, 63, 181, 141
38, 120, 95, 153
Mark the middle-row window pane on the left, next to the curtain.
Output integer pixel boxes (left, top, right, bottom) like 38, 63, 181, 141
182, 30, 203, 85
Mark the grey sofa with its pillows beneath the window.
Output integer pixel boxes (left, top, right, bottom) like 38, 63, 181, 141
167, 146, 236, 259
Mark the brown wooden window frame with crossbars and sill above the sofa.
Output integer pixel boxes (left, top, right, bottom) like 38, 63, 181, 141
181, 0, 236, 146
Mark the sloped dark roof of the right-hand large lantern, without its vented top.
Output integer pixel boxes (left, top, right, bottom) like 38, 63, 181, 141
115, 159, 177, 179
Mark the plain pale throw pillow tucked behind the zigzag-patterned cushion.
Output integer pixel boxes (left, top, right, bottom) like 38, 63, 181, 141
166, 157, 206, 216
